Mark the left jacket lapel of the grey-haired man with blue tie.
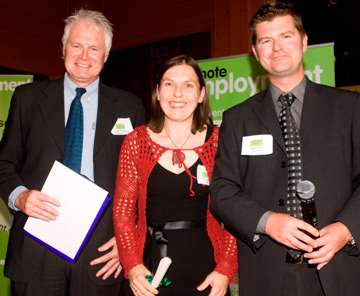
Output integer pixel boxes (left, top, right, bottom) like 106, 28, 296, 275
40, 79, 65, 153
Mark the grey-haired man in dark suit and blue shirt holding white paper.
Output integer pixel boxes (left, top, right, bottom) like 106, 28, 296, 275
0, 9, 145, 296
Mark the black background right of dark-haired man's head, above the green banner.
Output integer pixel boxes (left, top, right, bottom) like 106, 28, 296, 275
291, 0, 360, 87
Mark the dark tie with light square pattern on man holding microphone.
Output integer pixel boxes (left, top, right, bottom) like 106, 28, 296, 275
279, 93, 303, 259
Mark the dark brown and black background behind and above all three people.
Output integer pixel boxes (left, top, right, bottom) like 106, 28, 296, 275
0, 0, 360, 106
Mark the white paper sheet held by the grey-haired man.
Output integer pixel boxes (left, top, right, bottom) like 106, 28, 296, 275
24, 161, 108, 259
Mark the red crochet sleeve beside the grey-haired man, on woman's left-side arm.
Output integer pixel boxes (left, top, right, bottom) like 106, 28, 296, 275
113, 130, 143, 278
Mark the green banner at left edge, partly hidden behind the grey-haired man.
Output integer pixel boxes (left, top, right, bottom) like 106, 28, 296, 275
0, 75, 33, 296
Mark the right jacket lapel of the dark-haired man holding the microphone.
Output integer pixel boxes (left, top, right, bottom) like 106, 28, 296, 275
300, 80, 326, 147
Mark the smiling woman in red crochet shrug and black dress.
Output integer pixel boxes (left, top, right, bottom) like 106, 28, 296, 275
113, 56, 237, 296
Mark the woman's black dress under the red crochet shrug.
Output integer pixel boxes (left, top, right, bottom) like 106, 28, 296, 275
121, 128, 230, 296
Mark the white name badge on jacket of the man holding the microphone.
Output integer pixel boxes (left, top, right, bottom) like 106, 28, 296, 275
241, 135, 273, 155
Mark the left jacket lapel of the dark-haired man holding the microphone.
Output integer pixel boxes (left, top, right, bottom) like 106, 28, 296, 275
254, 89, 285, 152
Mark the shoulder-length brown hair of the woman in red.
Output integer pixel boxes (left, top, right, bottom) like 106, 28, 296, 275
148, 55, 213, 134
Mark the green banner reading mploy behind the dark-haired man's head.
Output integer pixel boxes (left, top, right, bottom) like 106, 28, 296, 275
199, 43, 335, 122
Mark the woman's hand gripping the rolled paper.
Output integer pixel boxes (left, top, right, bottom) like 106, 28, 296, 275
129, 264, 159, 296
